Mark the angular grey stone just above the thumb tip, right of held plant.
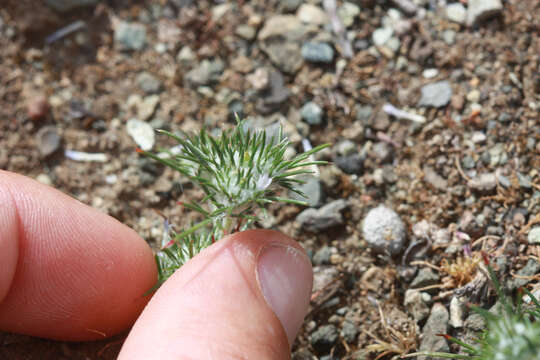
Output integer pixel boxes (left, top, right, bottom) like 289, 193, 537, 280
296, 199, 348, 232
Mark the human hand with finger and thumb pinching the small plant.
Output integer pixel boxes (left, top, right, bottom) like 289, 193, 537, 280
0, 170, 312, 359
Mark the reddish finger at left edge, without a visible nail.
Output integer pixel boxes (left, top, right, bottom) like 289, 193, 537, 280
0, 170, 157, 340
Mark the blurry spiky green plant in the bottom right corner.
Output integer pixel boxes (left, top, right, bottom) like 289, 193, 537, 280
402, 254, 540, 360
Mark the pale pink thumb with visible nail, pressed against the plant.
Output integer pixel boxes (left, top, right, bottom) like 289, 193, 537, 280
119, 230, 313, 359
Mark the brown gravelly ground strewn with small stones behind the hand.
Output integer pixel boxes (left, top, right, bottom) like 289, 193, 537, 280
0, 0, 540, 360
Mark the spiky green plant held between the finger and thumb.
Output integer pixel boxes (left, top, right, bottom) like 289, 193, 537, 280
137, 120, 328, 286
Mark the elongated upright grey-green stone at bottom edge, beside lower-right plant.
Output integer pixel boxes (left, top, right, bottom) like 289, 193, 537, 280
418, 303, 449, 360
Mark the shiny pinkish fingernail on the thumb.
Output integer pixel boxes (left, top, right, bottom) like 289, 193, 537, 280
257, 244, 313, 345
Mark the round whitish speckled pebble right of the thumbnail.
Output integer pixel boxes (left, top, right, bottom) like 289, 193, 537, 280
362, 205, 407, 256
